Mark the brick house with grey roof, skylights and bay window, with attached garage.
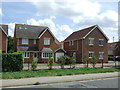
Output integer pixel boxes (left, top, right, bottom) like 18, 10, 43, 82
14, 24, 65, 62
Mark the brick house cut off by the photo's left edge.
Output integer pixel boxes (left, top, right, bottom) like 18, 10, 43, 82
0, 24, 8, 53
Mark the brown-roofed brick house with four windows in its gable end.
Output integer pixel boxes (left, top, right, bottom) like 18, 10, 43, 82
64, 25, 108, 63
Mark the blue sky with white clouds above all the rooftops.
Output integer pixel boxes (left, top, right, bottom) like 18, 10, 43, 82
0, 0, 118, 42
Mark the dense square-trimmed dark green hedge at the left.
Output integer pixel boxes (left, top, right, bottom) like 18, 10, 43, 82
2, 52, 23, 72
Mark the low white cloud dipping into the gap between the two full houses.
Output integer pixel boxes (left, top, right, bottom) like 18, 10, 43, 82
27, 18, 73, 41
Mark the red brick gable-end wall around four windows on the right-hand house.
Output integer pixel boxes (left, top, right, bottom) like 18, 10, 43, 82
84, 29, 108, 62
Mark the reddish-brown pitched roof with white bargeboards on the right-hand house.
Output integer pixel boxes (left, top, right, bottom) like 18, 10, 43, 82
64, 25, 108, 41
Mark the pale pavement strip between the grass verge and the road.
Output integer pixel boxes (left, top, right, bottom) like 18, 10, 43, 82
0, 72, 119, 88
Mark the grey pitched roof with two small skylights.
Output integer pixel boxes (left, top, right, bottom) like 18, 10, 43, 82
15, 24, 48, 39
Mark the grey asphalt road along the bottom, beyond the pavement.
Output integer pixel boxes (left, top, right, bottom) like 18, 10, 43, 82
4, 78, 120, 88
